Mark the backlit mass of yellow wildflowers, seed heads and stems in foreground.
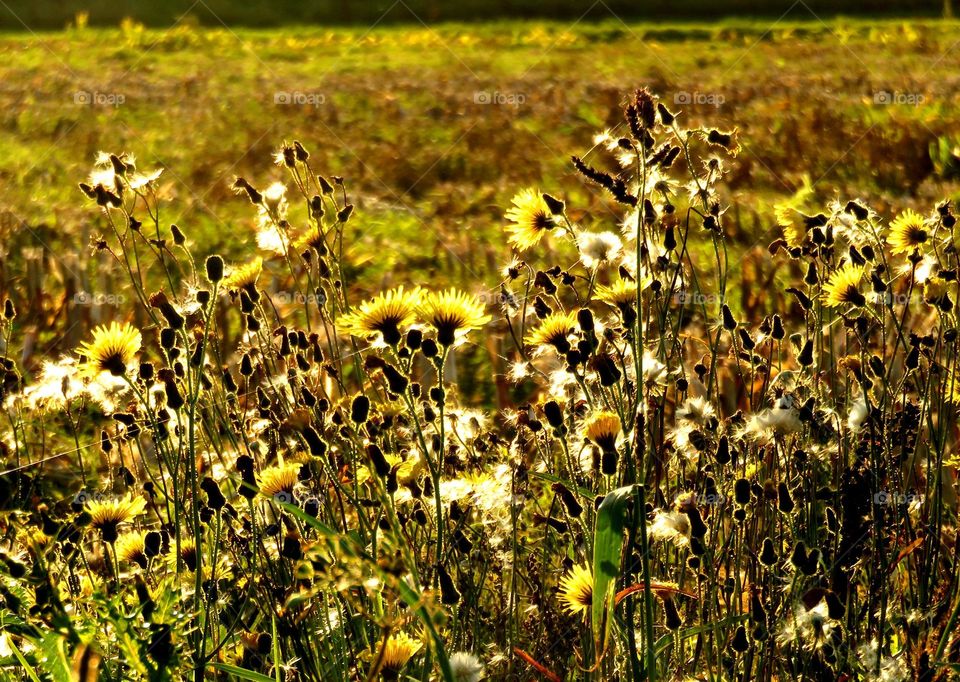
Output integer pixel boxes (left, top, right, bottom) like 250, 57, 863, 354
0, 90, 960, 682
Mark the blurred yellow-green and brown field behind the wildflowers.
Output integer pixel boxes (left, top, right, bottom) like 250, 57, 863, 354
0, 15, 960, 365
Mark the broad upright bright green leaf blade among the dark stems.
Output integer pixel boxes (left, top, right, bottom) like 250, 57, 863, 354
590, 485, 636, 652
